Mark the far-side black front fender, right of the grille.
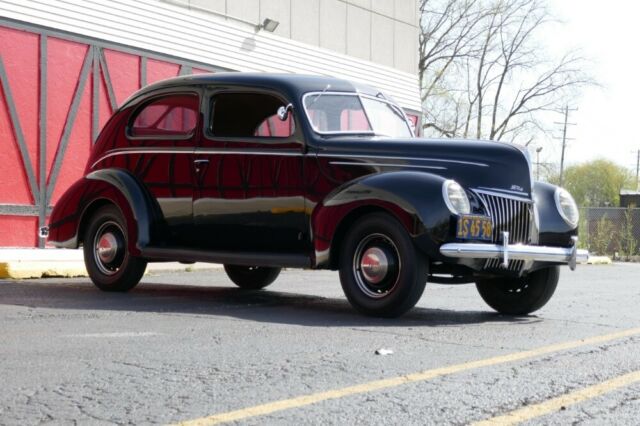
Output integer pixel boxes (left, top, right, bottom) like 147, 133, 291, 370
533, 182, 578, 247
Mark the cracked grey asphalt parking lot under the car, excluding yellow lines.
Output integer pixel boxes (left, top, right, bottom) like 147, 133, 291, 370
0, 264, 640, 425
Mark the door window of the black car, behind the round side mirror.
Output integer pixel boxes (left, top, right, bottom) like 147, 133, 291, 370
209, 93, 295, 138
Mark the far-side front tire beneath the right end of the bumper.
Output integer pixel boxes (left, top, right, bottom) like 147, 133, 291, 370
476, 266, 560, 315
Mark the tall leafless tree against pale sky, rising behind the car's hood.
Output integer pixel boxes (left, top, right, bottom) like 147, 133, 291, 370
419, 0, 591, 143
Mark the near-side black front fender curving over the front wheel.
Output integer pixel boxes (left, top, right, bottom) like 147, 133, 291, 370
311, 171, 452, 267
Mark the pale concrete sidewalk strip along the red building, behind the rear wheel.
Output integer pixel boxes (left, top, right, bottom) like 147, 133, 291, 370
0, 248, 222, 279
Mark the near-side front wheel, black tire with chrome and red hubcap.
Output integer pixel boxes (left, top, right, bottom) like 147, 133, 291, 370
339, 213, 428, 318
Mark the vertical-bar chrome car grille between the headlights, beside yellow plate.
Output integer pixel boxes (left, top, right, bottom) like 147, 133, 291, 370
475, 191, 532, 272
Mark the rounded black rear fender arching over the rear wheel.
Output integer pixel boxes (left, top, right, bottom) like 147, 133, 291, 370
49, 169, 158, 254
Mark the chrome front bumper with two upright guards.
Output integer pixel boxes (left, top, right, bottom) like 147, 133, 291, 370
440, 232, 589, 270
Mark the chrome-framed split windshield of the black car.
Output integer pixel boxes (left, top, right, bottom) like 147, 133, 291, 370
303, 92, 413, 138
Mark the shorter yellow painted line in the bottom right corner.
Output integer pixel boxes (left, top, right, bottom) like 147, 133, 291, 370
473, 371, 640, 426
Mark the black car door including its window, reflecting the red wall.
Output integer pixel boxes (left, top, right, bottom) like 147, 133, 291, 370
193, 89, 309, 254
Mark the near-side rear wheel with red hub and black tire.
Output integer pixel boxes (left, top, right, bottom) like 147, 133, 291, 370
83, 205, 147, 292
